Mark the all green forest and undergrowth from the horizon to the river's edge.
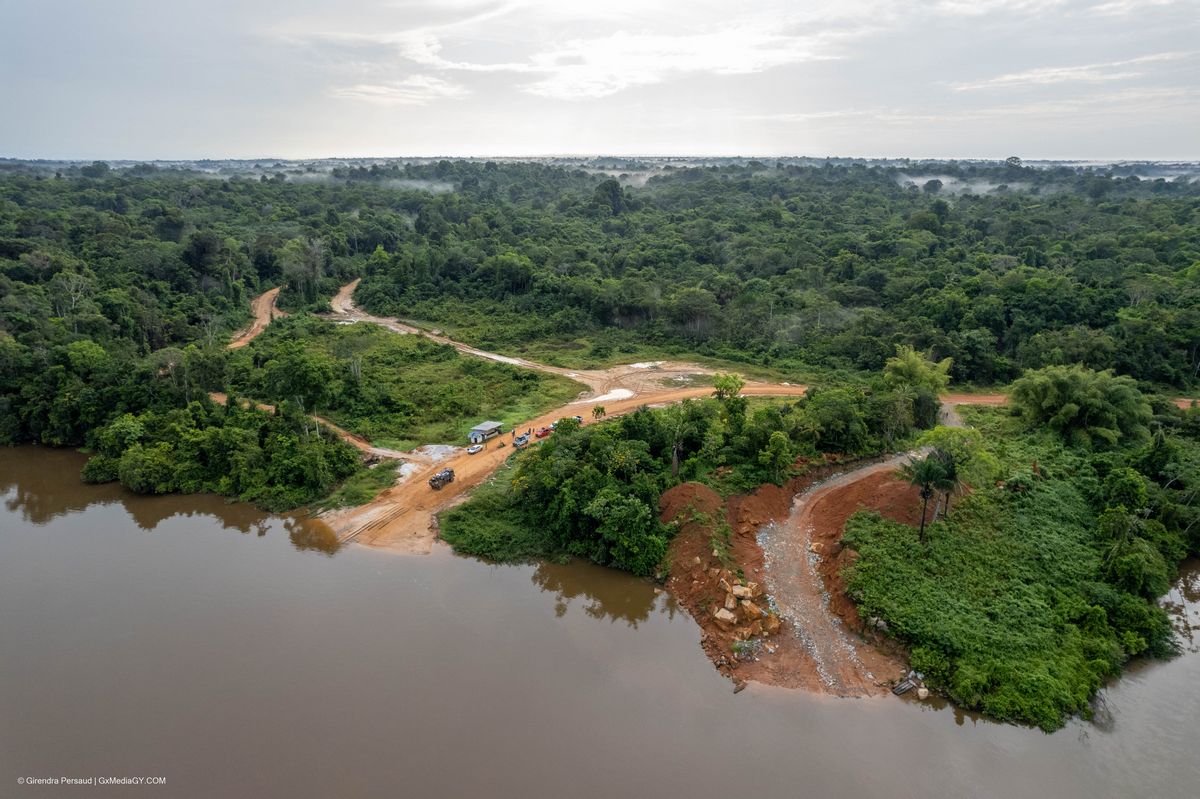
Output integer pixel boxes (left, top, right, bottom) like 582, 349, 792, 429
0, 161, 1200, 728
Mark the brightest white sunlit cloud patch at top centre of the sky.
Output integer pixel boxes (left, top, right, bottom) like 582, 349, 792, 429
277, 0, 884, 100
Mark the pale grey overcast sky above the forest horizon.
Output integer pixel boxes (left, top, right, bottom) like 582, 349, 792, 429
0, 0, 1200, 160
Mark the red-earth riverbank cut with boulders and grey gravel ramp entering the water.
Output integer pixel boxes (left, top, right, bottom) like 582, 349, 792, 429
660, 458, 919, 696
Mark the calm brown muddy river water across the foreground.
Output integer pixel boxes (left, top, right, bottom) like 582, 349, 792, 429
0, 447, 1200, 799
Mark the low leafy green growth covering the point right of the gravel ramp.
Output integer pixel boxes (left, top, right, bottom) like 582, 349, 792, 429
845, 409, 1171, 731
